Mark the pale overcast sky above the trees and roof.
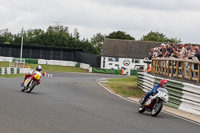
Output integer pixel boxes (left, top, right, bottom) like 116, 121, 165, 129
0, 0, 200, 44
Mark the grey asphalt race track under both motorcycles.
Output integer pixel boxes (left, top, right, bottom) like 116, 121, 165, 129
0, 73, 200, 133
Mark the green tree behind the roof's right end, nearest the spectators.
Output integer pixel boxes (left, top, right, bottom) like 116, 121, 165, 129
141, 31, 180, 43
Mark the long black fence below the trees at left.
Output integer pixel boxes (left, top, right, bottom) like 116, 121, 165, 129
0, 44, 101, 67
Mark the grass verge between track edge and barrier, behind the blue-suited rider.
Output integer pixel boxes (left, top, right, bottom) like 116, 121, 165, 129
104, 76, 145, 98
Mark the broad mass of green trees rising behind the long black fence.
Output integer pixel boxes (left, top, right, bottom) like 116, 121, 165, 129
0, 25, 100, 55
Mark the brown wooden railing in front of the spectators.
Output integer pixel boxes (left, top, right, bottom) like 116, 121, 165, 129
152, 58, 200, 83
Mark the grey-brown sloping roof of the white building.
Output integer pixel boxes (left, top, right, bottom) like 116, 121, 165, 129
102, 38, 161, 59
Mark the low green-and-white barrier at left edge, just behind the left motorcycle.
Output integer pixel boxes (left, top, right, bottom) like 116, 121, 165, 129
0, 67, 31, 75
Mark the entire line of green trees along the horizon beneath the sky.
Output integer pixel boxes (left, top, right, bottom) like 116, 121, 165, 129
0, 25, 180, 55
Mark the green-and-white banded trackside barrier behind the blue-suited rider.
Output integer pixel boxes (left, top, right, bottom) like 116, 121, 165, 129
138, 73, 200, 115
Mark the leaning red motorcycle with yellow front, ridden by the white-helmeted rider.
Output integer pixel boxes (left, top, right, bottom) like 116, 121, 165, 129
21, 72, 41, 93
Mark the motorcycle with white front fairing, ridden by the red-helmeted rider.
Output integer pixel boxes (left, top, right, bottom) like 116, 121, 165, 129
138, 87, 169, 117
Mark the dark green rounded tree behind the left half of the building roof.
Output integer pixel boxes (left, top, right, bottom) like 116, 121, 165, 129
106, 31, 135, 40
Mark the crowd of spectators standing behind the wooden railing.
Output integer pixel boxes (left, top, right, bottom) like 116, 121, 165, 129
149, 43, 200, 61
